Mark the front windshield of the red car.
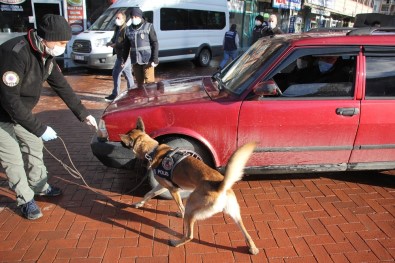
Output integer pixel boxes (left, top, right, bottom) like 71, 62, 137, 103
220, 37, 286, 95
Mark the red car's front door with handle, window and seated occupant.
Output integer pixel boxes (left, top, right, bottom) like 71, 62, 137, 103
238, 47, 360, 173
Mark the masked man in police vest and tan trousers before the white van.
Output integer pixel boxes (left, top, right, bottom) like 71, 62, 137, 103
123, 7, 159, 88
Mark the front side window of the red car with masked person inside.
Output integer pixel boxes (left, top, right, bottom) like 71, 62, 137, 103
273, 54, 356, 97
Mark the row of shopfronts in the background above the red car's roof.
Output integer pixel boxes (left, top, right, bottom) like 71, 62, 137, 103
228, 0, 374, 48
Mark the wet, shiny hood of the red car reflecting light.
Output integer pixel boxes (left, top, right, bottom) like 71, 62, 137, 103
106, 76, 219, 113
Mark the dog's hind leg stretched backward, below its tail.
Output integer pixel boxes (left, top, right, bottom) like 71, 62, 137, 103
224, 191, 259, 255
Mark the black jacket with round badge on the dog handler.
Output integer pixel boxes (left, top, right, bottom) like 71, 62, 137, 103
0, 30, 89, 137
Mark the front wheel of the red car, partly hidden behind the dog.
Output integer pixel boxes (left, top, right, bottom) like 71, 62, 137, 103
147, 137, 214, 199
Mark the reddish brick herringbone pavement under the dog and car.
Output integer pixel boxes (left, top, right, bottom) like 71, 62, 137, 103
0, 63, 395, 263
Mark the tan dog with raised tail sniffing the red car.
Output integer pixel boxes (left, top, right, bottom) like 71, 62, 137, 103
120, 117, 259, 255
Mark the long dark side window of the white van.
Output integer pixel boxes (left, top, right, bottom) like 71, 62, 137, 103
160, 8, 226, 31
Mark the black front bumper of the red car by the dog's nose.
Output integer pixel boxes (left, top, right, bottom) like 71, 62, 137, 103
91, 135, 136, 170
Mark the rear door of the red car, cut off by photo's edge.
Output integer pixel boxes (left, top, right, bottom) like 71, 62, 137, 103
350, 46, 395, 169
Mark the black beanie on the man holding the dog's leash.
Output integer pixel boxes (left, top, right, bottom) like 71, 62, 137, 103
37, 14, 71, 41
